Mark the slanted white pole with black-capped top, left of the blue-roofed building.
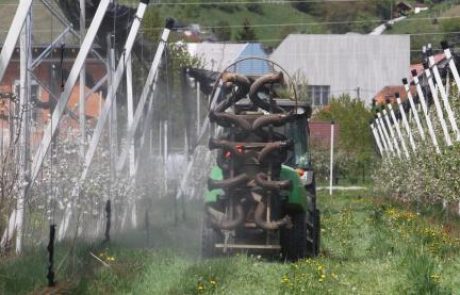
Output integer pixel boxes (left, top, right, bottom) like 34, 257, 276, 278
116, 28, 171, 172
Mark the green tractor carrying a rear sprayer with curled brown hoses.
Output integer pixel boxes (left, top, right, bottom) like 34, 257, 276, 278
201, 60, 320, 261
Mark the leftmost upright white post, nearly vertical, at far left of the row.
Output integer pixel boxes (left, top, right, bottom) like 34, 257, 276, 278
16, 11, 32, 254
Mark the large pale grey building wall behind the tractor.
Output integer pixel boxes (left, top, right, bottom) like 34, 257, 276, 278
270, 34, 410, 106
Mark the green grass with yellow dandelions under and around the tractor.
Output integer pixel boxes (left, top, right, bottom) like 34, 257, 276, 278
0, 192, 460, 294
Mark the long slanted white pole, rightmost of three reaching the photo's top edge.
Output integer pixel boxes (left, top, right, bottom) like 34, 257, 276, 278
58, 0, 148, 240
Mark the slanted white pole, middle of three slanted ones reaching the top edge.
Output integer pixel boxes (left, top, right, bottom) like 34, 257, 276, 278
31, 0, 111, 185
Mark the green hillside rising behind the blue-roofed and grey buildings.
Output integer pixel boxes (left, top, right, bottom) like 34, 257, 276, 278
120, 0, 392, 46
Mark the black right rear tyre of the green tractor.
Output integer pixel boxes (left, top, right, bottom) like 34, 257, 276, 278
280, 212, 307, 261
